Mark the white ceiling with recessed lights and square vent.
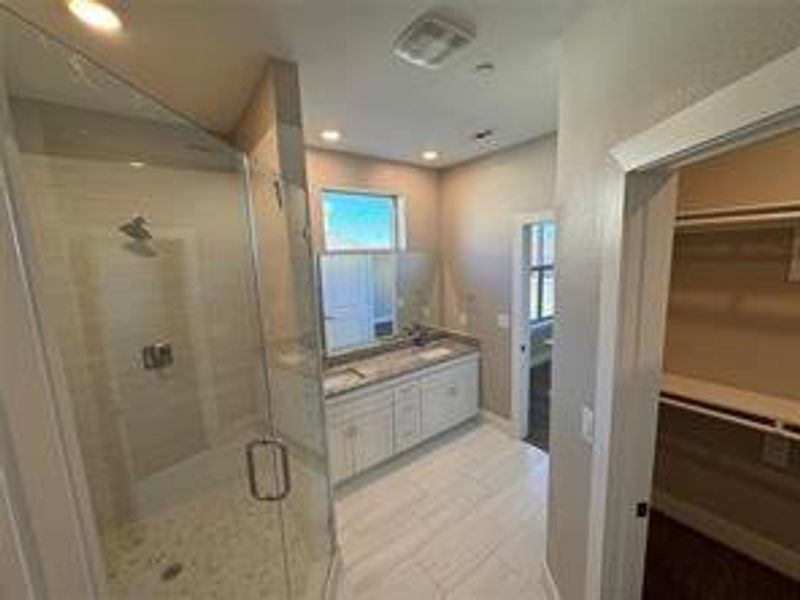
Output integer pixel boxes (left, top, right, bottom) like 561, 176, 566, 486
1, 0, 583, 165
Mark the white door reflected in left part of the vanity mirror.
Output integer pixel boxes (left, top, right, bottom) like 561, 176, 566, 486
320, 254, 375, 350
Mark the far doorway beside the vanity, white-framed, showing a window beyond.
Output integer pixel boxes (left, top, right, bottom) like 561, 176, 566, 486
511, 213, 557, 452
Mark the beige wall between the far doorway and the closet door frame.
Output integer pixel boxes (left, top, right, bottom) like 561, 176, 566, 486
547, 0, 800, 600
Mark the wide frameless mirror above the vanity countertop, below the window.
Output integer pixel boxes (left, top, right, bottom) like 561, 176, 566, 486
320, 251, 439, 354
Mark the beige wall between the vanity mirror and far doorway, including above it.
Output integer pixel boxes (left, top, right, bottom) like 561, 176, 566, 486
440, 136, 556, 417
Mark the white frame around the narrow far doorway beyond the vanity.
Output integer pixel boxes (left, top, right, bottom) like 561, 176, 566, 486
510, 210, 558, 439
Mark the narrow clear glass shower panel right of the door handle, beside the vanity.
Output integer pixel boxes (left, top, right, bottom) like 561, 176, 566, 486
244, 170, 334, 600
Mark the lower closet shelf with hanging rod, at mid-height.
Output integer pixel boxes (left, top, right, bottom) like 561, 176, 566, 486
661, 373, 800, 441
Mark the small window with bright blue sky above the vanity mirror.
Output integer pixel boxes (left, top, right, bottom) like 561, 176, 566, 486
322, 191, 398, 252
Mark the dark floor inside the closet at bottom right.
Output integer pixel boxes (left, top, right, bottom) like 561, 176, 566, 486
642, 511, 800, 600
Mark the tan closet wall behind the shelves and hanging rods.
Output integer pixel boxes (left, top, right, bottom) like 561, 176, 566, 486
654, 132, 800, 578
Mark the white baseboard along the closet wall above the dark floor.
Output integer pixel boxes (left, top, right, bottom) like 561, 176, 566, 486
652, 490, 800, 580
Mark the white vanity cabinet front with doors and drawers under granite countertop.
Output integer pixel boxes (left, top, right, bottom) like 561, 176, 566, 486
326, 353, 479, 483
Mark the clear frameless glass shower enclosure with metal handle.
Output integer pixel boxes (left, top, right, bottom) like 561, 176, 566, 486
0, 10, 334, 600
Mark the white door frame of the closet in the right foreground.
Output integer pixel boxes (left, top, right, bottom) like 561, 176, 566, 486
585, 49, 800, 600
